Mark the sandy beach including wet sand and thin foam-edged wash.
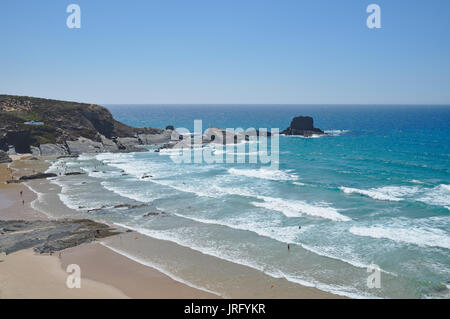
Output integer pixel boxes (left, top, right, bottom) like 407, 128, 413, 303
0, 155, 339, 299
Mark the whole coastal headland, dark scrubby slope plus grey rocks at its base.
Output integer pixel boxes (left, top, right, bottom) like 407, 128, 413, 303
0, 95, 171, 156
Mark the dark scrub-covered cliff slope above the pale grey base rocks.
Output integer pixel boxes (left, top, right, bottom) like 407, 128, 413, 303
0, 95, 160, 152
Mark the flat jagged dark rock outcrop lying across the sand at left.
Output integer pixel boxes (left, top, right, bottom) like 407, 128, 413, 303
0, 219, 119, 254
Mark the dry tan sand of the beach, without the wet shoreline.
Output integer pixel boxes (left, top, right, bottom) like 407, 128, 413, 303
0, 156, 217, 298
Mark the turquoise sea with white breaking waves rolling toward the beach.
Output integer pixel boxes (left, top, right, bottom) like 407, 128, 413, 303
46, 105, 450, 298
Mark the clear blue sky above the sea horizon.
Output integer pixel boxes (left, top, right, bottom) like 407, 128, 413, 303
0, 0, 450, 104
